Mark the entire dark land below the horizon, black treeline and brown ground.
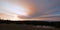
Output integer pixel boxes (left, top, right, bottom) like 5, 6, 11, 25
0, 20, 60, 30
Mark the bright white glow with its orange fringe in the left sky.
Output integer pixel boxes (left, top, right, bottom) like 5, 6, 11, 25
0, 1, 34, 21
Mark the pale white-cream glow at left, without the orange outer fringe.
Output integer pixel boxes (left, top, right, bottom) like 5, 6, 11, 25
0, 2, 29, 21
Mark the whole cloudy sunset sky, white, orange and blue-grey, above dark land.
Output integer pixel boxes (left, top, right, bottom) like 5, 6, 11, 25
0, 0, 60, 21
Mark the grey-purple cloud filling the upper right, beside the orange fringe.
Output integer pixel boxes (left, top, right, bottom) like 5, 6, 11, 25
23, 0, 60, 17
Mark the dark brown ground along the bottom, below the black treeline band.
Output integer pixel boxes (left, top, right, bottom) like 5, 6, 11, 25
0, 24, 60, 30
